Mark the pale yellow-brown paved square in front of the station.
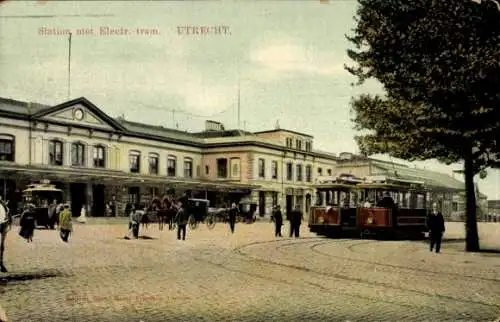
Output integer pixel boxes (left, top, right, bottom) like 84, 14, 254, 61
0, 220, 500, 322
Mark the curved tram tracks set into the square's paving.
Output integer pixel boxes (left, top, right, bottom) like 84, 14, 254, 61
206, 237, 500, 310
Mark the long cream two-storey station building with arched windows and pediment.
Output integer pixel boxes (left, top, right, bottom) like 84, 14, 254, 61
0, 97, 476, 216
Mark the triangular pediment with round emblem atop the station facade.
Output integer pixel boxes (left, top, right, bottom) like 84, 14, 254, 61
33, 97, 126, 132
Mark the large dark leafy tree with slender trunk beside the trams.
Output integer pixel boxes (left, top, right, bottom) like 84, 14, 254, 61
346, 0, 500, 251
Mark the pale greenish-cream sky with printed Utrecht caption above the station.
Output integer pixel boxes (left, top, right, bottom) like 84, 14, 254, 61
0, 0, 500, 199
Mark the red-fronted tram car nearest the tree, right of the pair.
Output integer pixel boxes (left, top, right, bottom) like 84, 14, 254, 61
357, 176, 428, 239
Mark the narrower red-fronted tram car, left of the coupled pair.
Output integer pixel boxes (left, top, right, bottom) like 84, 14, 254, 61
308, 174, 363, 237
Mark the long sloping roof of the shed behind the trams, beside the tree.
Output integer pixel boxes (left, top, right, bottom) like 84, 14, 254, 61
372, 159, 465, 190
